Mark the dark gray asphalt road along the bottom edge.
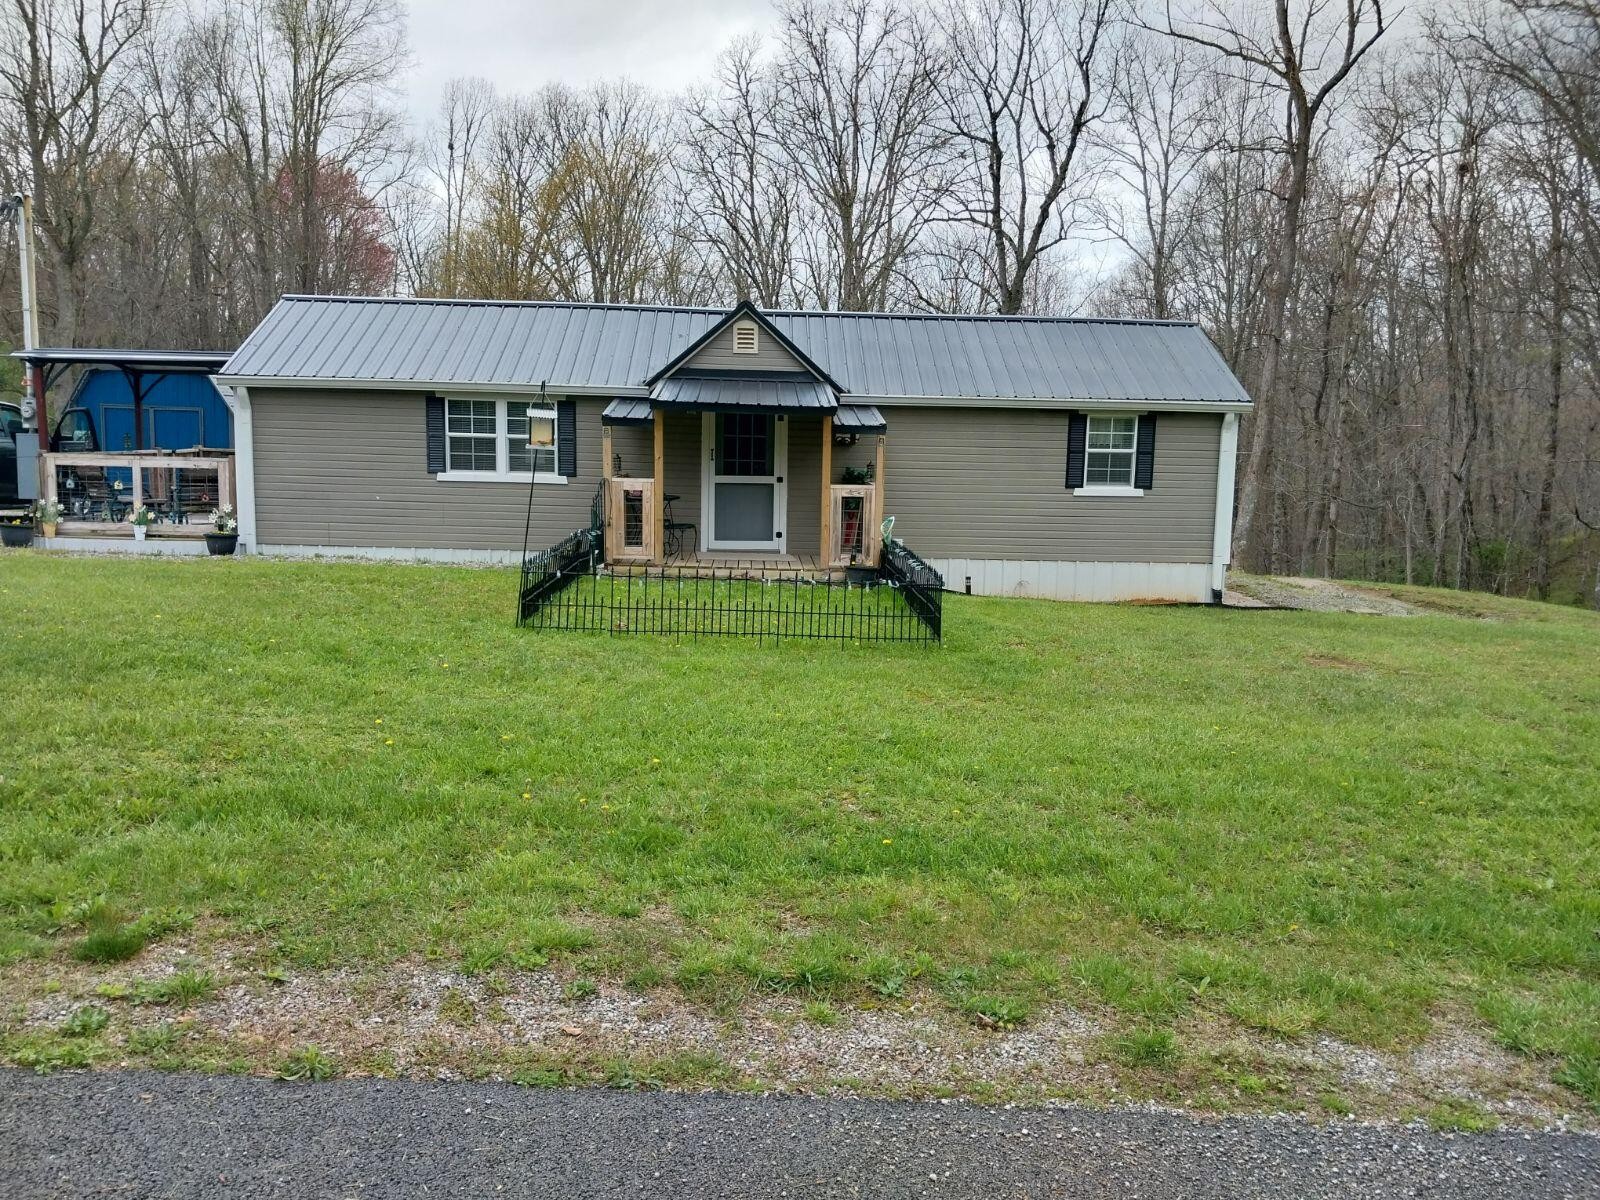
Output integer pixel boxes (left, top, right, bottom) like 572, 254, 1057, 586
0, 1072, 1600, 1200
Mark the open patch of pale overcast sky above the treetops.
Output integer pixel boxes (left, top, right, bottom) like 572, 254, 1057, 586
397, 0, 773, 123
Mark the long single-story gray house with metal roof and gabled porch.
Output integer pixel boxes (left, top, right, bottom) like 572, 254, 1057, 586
218, 296, 1250, 602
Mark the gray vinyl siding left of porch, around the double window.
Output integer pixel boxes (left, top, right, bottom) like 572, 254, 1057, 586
250, 389, 605, 550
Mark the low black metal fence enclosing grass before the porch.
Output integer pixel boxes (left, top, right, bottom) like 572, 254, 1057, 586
517, 530, 944, 642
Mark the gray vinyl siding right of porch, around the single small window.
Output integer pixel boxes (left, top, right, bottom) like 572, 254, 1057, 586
883, 406, 1222, 563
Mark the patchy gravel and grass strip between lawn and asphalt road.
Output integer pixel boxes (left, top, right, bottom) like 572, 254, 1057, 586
0, 939, 1597, 1128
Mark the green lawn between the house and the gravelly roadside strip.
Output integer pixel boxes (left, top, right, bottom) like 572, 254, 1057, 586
0, 552, 1600, 1101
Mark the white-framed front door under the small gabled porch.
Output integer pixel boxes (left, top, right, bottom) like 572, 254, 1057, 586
701, 413, 789, 554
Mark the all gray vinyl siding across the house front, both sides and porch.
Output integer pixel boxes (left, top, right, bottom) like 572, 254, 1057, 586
251, 389, 1221, 563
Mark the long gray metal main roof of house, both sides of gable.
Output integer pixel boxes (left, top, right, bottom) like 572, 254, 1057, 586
222, 296, 1250, 405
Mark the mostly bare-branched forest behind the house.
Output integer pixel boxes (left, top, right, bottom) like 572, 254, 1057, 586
0, 0, 1600, 606
